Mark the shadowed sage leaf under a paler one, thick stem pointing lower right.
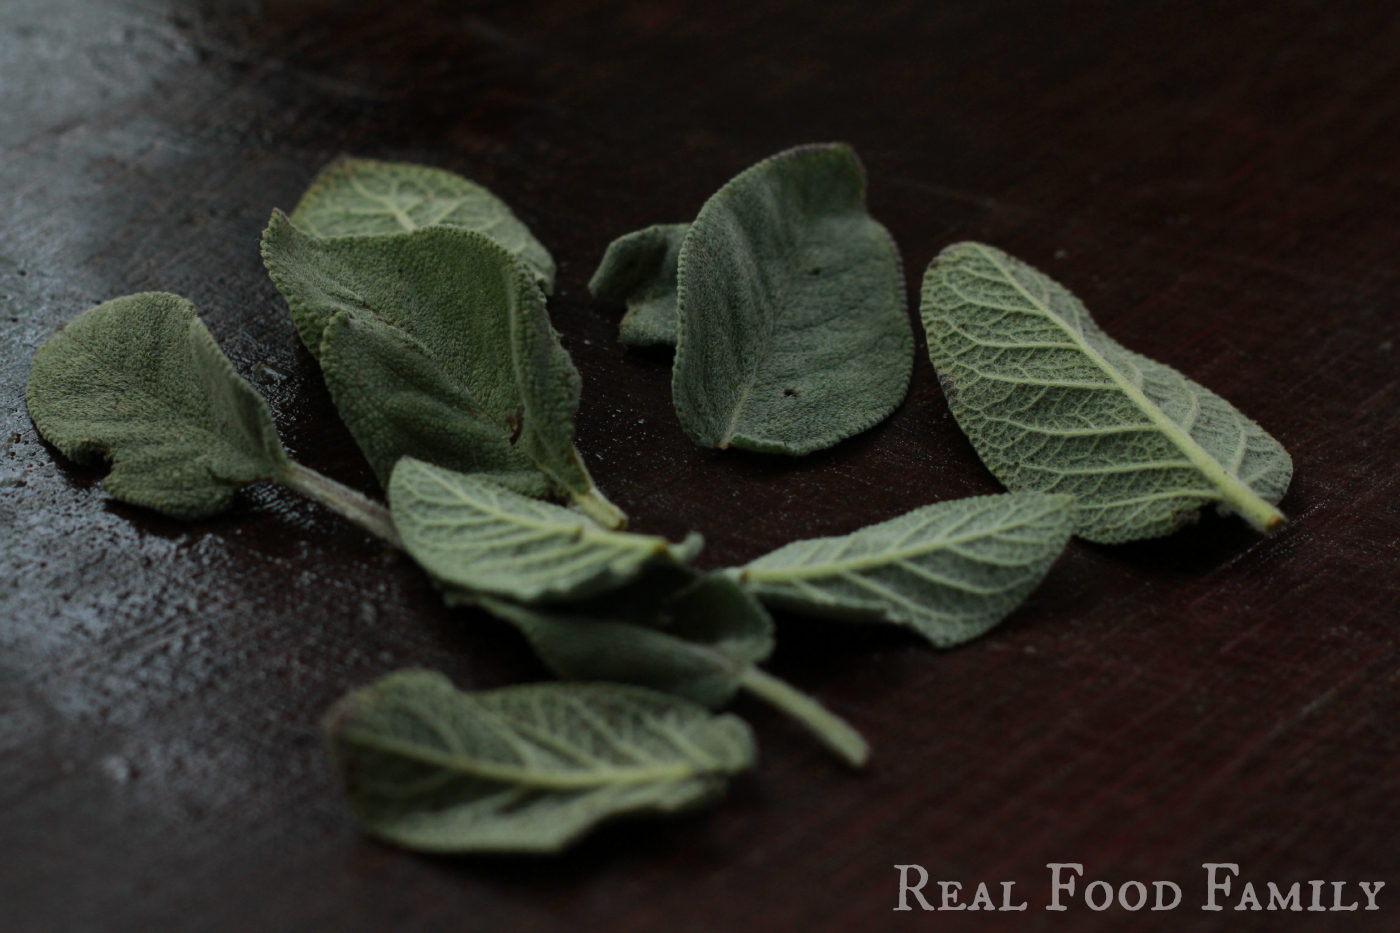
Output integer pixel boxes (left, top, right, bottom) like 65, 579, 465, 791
476, 566, 869, 768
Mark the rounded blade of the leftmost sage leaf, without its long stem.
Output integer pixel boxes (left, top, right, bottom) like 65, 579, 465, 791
27, 291, 290, 518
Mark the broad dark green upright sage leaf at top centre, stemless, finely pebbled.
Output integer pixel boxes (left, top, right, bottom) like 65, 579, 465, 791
671, 144, 914, 455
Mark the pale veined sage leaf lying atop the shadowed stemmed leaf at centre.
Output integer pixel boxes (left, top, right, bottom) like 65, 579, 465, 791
389, 457, 701, 602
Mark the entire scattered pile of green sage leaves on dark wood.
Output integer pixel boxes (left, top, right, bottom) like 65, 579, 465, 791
28, 144, 1292, 852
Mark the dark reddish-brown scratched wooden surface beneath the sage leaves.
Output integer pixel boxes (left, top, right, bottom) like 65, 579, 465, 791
0, 0, 1400, 933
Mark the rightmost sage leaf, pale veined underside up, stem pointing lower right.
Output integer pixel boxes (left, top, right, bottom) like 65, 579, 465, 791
923, 242, 1292, 544
